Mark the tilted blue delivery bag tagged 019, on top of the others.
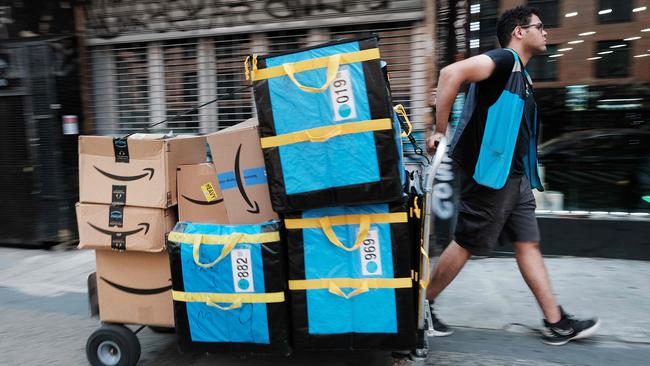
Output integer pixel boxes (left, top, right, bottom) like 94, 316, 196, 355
251, 37, 402, 213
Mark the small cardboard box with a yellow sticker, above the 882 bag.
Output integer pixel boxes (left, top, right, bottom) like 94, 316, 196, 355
178, 163, 228, 224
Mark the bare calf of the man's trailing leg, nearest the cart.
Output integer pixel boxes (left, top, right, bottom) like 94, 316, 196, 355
427, 241, 472, 302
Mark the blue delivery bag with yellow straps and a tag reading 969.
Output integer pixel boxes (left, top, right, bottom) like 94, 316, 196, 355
285, 203, 417, 350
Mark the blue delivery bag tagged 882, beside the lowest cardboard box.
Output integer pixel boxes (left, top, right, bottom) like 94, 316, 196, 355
167, 221, 290, 353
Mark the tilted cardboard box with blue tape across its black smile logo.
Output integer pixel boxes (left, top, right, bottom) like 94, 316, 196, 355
207, 118, 278, 224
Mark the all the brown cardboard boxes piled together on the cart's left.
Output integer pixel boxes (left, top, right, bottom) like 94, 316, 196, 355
76, 119, 278, 327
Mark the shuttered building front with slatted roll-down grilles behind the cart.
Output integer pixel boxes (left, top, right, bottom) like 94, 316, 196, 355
82, 0, 434, 146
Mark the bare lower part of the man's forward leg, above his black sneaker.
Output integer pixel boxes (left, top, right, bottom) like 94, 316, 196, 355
515, 241, 562, 323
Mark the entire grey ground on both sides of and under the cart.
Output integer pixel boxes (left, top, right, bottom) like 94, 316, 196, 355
0, 247, 650, 366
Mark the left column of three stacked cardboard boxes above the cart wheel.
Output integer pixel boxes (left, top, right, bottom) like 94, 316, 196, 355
77, 134, 206, 327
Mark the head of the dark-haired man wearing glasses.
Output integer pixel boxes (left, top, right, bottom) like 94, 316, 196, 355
497, 6, 547, 54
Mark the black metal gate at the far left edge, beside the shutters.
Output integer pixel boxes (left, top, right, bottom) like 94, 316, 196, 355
0, 37, 81, 246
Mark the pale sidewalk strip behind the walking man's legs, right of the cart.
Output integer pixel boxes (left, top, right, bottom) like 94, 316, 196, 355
436, 257, 650, 344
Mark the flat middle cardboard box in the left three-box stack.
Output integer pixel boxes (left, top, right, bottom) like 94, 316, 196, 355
76, 203, 176, 252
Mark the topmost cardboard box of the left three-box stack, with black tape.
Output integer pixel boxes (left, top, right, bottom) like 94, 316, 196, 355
79, 134, 206, 208
